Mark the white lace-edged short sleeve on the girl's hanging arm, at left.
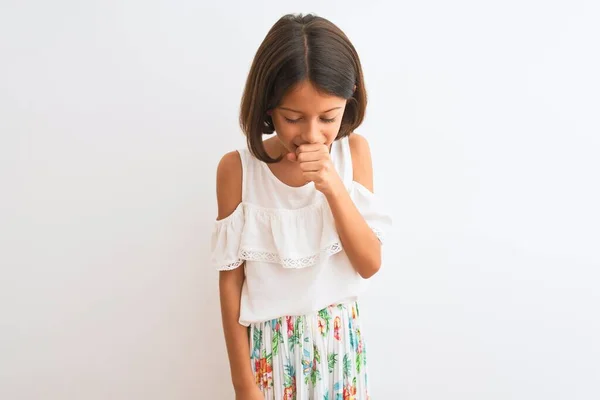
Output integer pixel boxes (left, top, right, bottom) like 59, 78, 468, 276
211, 204, 245, 271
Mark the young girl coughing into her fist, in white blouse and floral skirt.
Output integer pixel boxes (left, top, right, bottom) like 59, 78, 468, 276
212, 15, 391, 400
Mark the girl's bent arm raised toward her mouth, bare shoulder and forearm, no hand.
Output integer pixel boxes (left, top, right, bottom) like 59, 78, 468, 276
326, 133, 381, 279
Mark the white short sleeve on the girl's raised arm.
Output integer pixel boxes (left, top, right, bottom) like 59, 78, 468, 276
350, 181, 392, 244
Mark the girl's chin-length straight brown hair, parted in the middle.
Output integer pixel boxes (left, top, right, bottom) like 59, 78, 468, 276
240, 14, 367, 163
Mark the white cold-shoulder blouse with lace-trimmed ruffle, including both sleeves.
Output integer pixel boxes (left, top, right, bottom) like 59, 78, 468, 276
211, 137, 391, 326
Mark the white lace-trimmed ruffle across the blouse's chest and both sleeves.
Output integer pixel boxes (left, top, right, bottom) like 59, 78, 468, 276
211, 182, 391, 270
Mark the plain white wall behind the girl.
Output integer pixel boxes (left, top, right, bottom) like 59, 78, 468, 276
0, 0, 600, 400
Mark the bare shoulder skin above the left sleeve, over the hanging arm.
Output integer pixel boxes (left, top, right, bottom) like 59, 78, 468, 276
217, 151, 242, 220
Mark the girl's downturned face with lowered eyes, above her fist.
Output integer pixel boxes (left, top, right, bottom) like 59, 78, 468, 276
271, 81, 347, 152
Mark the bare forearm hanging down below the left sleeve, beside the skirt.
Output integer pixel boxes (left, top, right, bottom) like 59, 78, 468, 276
219, 266, 255, 390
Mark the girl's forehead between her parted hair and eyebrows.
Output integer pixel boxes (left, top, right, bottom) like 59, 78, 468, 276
279, 81, 346, 113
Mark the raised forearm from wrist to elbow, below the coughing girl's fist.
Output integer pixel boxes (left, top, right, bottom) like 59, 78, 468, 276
327, 190, 381, 279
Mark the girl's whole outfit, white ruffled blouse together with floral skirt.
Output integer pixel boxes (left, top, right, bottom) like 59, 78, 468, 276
211, 138, 391, 400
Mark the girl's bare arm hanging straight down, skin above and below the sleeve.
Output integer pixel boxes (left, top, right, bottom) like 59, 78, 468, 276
217, 152, 257, 392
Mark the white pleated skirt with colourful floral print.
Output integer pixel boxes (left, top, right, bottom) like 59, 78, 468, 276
249, 302, 369, 400
